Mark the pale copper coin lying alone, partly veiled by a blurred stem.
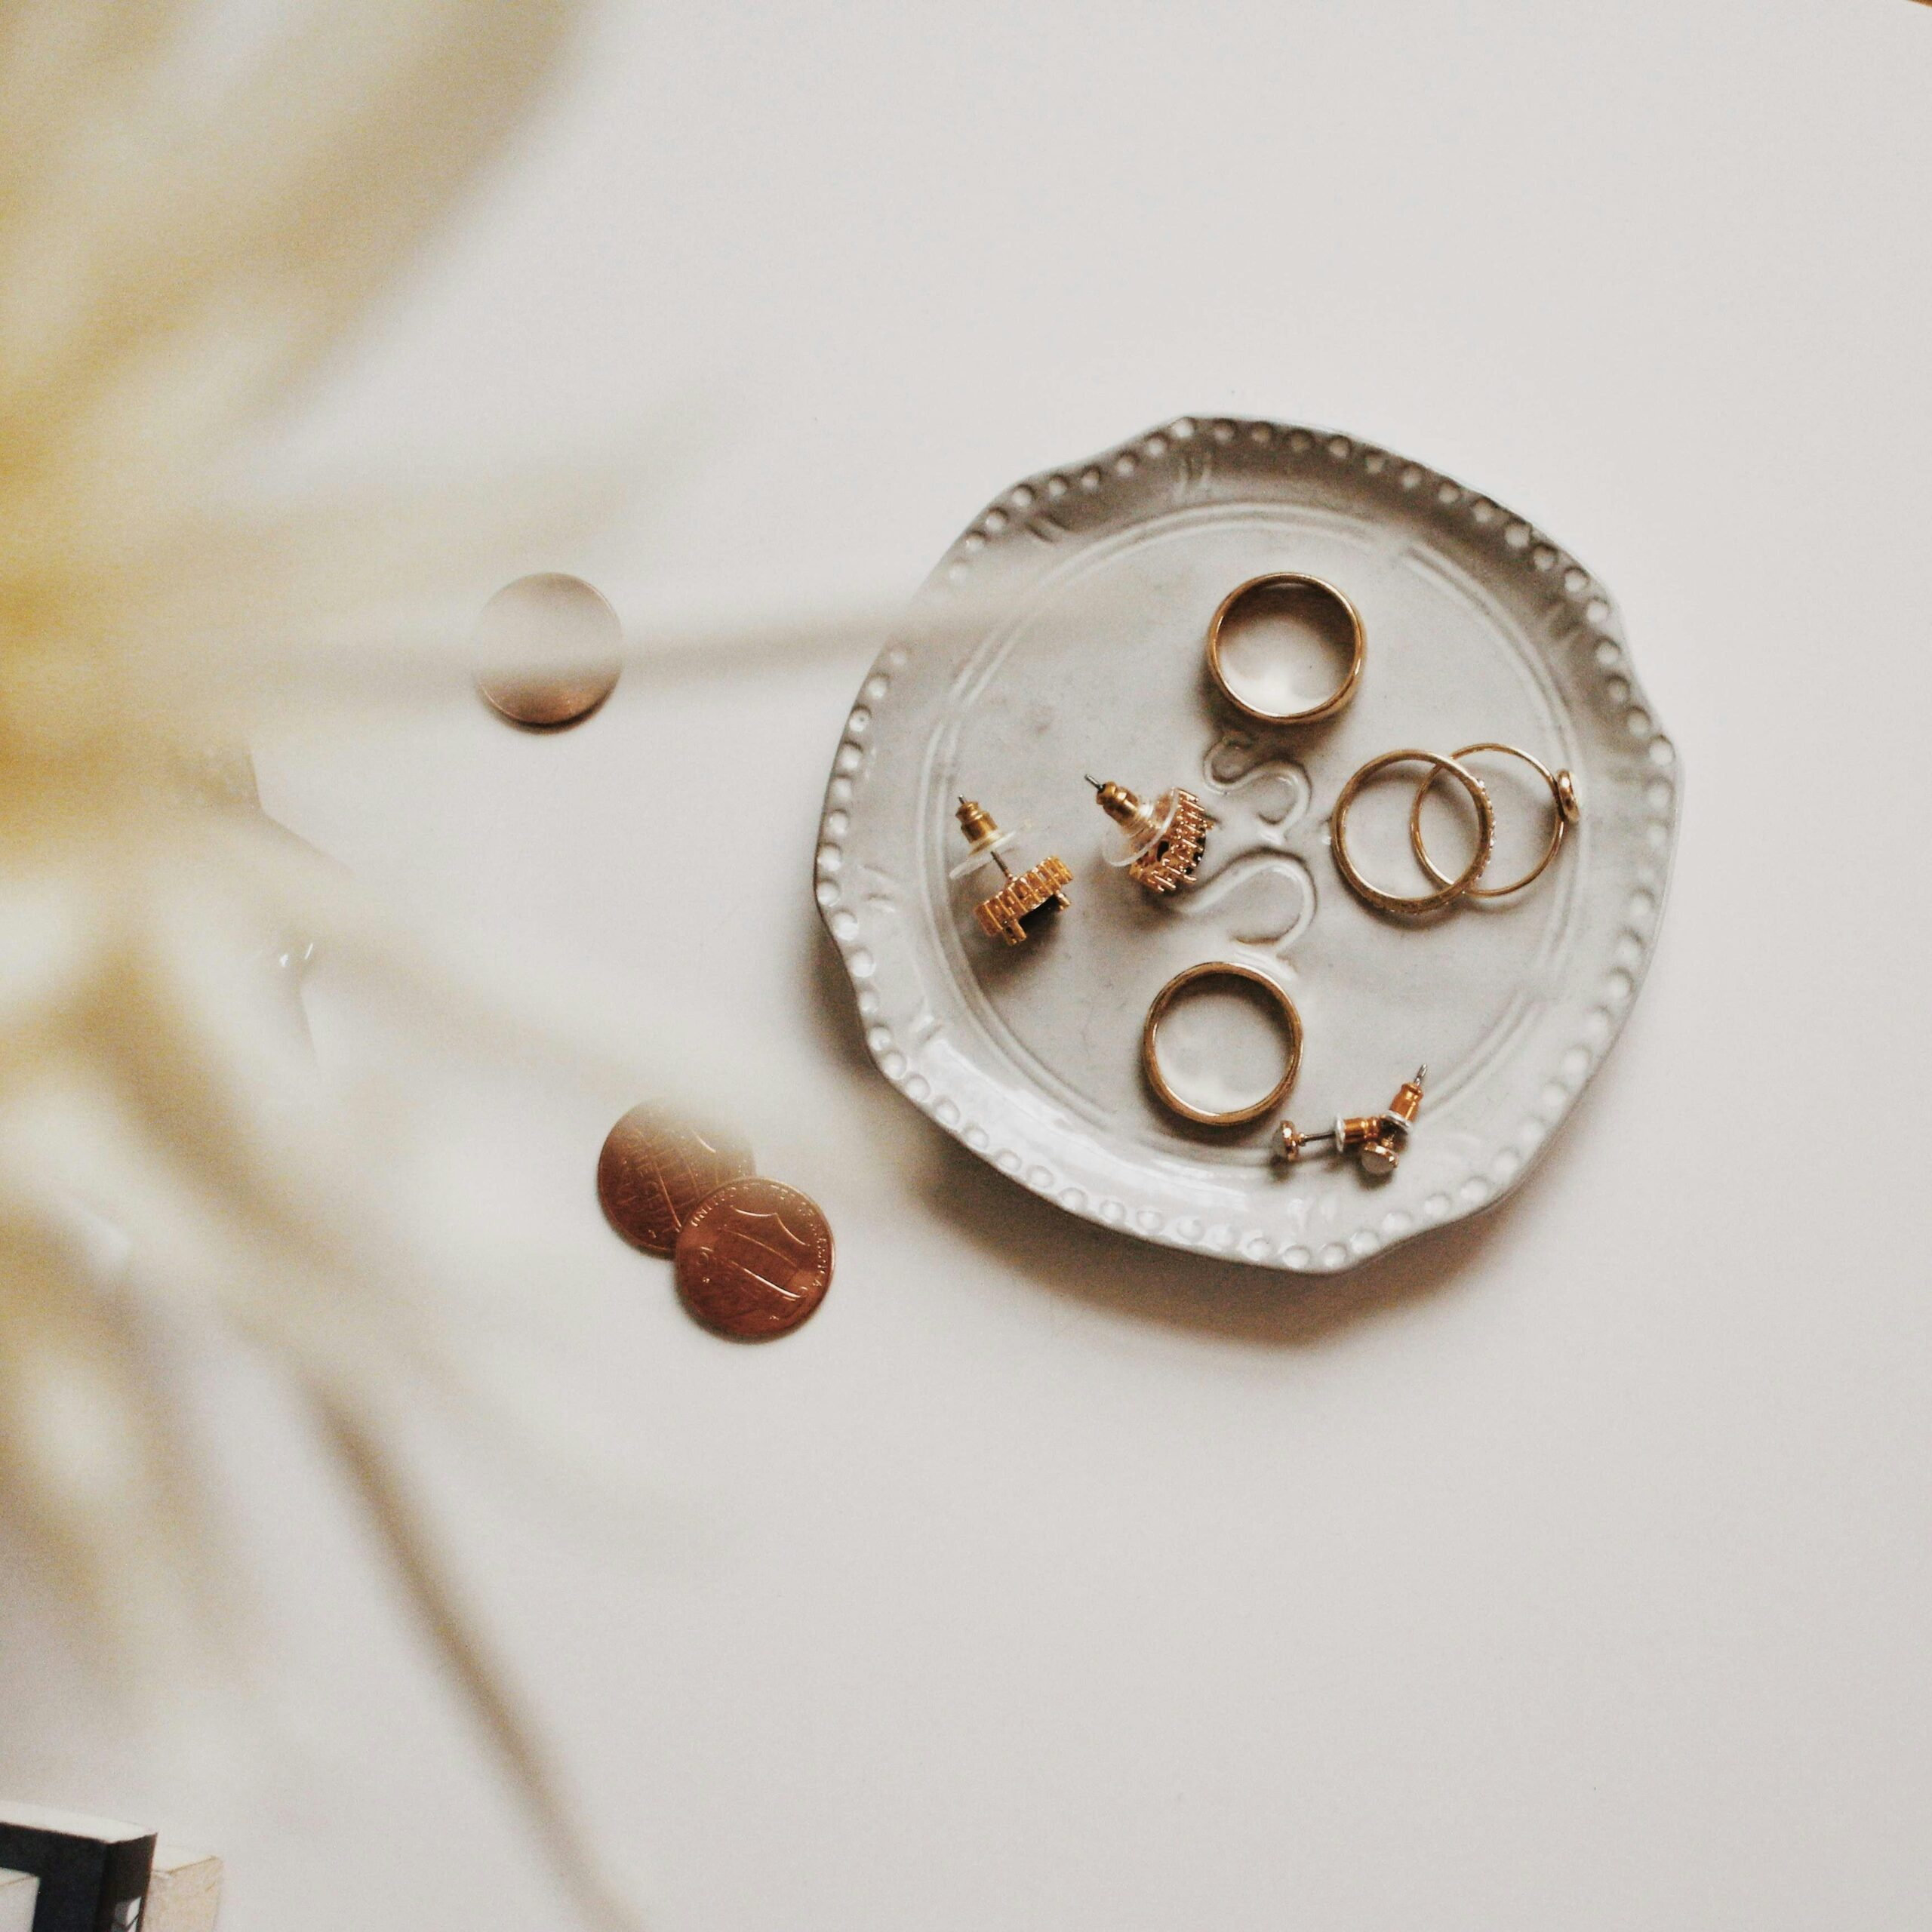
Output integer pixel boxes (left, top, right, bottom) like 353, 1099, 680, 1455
475, 570, 624, 731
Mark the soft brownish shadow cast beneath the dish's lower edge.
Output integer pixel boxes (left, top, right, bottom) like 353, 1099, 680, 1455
811, 921, 1588, 1346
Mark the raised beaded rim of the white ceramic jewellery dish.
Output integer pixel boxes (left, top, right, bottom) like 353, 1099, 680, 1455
814, 415, 1683, 1273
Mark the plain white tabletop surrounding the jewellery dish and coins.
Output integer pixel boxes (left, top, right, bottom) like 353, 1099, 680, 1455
0, 0, 1932, 1932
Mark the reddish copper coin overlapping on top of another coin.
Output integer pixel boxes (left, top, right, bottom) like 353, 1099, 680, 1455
678, 1180, 832, 1341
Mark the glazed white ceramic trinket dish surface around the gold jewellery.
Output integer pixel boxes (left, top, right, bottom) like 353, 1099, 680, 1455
815, 417, 1679, 1271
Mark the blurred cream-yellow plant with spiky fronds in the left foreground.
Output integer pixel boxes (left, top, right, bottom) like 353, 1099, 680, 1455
0, 0, 904, 1924
